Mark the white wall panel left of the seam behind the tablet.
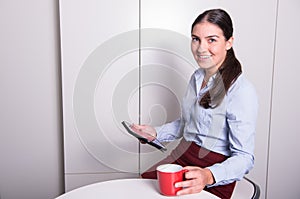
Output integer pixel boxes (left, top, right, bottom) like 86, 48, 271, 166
60, 0, 139, 190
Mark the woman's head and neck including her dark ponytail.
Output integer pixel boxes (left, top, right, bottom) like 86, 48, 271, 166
191, 10, 242, 108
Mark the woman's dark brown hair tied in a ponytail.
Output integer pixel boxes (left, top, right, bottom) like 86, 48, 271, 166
192, 9, 242, 108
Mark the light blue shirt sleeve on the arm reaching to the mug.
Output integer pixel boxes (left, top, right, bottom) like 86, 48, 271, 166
208, 77, 258, 186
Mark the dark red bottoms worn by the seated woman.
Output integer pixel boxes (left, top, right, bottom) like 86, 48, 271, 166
142, 139, 235, 199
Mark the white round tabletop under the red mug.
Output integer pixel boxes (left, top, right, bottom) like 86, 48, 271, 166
56, 179, 218, 199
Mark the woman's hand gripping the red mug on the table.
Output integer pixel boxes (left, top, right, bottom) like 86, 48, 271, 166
175, 166, 214, 195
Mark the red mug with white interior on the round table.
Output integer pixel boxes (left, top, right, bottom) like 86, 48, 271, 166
156, 164, 187, 196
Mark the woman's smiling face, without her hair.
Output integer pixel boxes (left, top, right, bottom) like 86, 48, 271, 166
191, 22, 233, 77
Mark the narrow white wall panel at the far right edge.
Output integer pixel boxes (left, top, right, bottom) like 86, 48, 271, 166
267, 0, 300, 199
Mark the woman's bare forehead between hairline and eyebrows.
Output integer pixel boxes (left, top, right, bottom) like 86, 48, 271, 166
192, 21, 223, 37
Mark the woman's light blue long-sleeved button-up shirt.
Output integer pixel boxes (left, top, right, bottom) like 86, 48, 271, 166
156, 69, 258, 186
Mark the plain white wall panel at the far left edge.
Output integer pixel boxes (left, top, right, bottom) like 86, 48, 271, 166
0, 0, 63, 199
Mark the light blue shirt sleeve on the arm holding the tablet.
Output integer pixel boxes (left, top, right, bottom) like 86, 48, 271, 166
155, 118, 183, 142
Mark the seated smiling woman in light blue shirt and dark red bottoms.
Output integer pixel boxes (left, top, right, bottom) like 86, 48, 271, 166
133, 9, 258, 198
